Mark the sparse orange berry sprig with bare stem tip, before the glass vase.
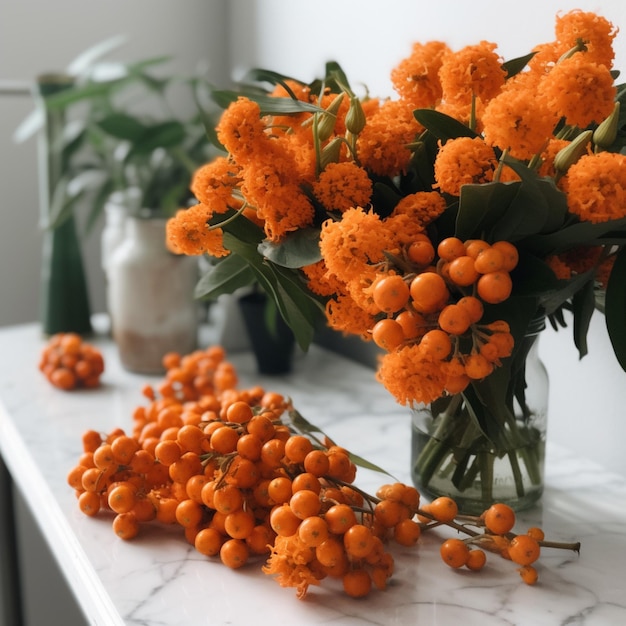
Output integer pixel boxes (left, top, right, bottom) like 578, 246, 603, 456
420, 496, 580, 585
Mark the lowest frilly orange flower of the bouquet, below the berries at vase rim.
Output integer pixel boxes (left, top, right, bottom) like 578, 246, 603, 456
376, 344, 448, 405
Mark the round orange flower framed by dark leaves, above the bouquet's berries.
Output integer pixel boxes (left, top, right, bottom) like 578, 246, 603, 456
435, 137, 498, 196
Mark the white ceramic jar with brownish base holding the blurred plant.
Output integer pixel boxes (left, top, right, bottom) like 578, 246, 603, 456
107, 216, 199, 374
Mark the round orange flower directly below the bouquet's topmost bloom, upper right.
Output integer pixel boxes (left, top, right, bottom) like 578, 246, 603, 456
539, 53, 616, 128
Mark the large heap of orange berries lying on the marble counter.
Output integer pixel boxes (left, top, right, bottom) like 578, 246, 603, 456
67, 347, 576, 598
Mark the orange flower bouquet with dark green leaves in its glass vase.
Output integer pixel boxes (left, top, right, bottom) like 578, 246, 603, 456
168, 10, 626, 511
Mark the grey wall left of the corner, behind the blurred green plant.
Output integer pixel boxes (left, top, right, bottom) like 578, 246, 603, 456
0, 0, 229, 326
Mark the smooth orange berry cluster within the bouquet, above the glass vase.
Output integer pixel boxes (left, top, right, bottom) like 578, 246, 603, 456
368, 235, 518, 393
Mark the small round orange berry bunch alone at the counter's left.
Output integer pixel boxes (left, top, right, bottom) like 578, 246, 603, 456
39, 333, 104, 391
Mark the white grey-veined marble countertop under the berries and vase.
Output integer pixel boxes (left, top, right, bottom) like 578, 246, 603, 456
0, 325, 626, 626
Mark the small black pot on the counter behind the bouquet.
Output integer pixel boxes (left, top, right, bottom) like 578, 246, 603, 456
239, 293, 295, 375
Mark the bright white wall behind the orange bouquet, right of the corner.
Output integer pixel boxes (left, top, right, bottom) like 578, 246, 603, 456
232, 0, 626, 474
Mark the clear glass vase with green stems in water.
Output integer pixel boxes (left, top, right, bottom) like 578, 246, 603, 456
411, 318, 548, 515
